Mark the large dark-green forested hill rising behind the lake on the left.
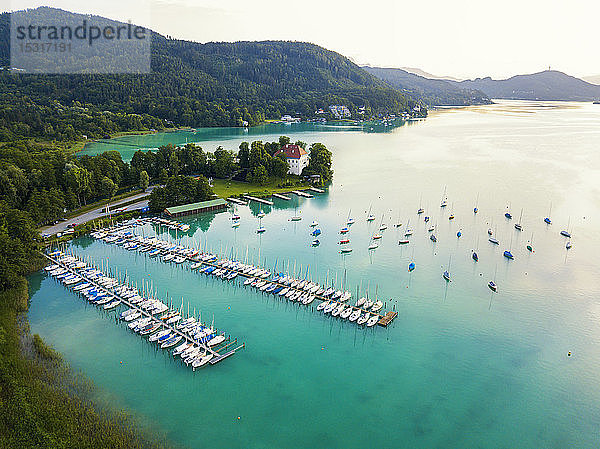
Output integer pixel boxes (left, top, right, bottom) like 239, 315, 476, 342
0, 7, 415, 140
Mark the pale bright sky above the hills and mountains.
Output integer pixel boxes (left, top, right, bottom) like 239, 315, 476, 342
0, 0, 600, 79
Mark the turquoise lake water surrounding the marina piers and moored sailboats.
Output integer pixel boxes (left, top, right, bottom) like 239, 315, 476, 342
29, 102, 600, 448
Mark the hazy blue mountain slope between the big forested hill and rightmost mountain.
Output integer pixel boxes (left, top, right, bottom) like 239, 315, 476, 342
363, 66, 491, 106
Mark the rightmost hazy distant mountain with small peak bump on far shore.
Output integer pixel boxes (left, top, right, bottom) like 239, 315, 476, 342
449, 70, 600, 101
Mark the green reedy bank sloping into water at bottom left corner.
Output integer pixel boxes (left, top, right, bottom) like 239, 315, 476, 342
0, 278, 173, 449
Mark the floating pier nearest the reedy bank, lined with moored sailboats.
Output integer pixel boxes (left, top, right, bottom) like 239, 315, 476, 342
44, 251, 245, 369
